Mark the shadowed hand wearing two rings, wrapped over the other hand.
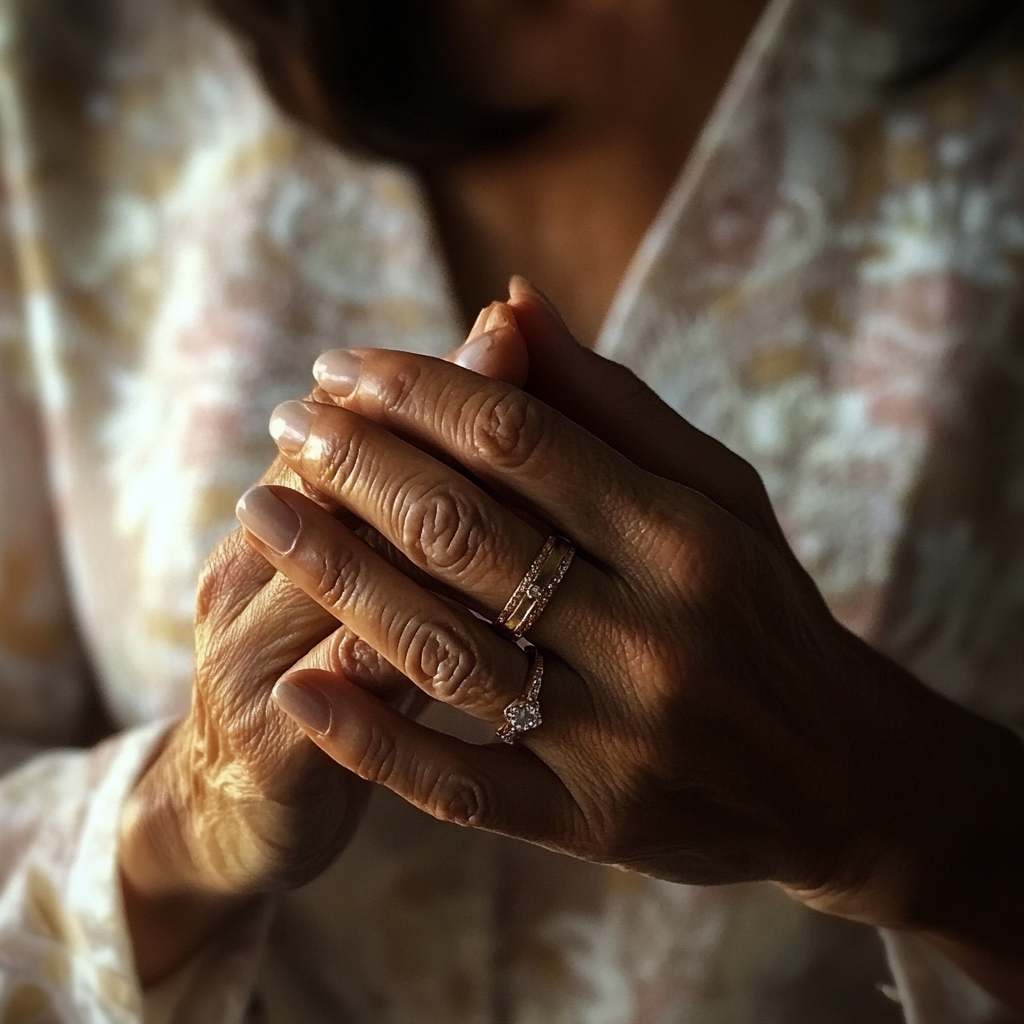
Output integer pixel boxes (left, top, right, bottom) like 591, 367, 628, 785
247, 289, 1024, 1007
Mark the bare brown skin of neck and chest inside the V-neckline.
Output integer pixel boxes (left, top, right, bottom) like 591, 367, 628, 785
423, 0, 765, 345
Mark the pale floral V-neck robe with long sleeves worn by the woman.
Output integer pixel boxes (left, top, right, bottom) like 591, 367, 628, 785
0, 0, 1024, 1024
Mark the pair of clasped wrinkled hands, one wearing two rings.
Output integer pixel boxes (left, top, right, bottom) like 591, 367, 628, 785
121, 282, 1024, 1001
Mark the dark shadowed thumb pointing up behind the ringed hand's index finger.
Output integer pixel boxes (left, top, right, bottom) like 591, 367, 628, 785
509, 276, 784, 543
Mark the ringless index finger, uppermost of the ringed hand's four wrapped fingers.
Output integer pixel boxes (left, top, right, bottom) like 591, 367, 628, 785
307, 349, 649, 568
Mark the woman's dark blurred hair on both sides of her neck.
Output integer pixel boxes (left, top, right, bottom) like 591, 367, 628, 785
208, 0, 1024, 167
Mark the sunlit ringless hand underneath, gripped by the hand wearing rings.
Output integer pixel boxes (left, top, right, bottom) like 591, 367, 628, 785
120, 311, 526, 983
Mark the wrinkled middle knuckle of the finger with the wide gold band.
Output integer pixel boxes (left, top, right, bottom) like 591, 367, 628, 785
401, 486, 493, 573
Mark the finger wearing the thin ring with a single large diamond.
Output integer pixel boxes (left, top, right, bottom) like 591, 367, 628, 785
239, 487, 552, 726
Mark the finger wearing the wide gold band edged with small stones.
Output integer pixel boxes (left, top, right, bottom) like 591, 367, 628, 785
271, 395, 614, 652
